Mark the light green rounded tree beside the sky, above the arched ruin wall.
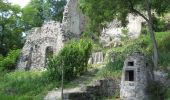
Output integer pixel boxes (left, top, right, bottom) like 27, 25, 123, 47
22, 0, 44, 30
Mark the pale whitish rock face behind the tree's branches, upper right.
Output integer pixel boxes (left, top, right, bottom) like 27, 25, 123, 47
100, 14, 144, 47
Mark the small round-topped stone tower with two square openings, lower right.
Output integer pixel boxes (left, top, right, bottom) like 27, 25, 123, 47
120, 53, 152, 100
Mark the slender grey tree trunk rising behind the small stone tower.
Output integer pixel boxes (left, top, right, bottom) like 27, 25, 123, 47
146, 0, 158, 68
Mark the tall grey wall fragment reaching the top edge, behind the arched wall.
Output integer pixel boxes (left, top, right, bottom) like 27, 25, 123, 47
62, 0, 85, 35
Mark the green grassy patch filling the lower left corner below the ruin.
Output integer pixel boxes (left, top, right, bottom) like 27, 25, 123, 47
0, 71, 59, 100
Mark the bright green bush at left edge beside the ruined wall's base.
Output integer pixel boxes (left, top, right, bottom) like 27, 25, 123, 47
0, 50, 20, 70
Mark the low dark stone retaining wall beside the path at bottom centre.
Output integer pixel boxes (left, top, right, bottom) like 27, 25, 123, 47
64, 79, 118, 100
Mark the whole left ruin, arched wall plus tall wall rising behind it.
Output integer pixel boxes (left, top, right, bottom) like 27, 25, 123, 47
17, 0, 85, 70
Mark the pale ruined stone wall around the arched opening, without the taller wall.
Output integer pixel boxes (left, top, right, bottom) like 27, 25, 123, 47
17, 21, 63, 70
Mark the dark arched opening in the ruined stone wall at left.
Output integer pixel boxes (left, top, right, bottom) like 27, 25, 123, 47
45, 46, 54, 66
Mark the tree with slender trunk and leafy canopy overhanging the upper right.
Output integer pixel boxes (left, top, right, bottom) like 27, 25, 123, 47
80, 0, 170, 67
